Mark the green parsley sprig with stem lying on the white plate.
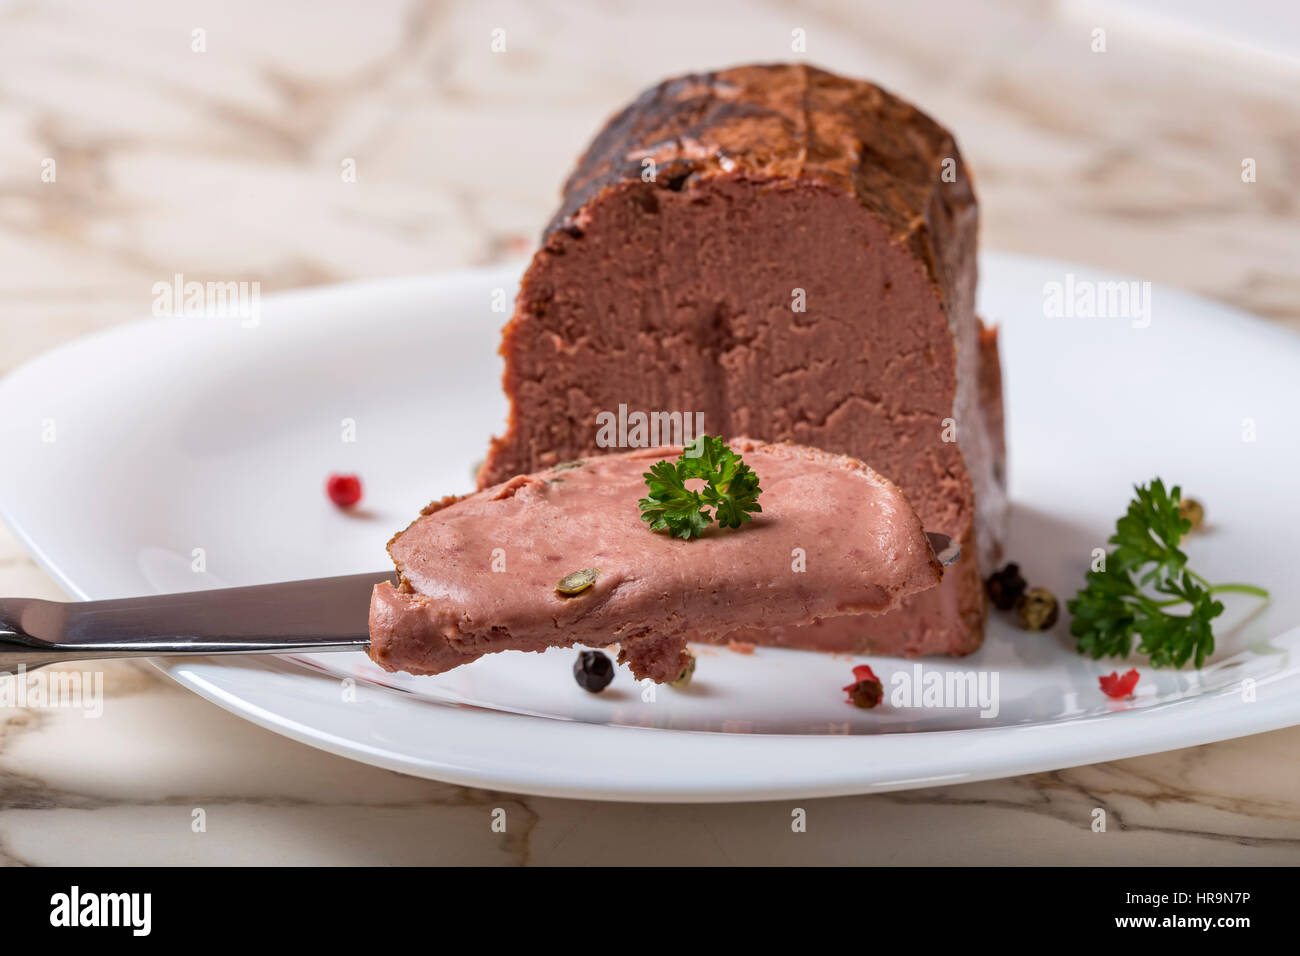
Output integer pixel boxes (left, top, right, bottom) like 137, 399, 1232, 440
1066, 479, 1269, 667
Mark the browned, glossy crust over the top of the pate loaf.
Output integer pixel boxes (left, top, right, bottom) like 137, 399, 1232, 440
542, 64, 979, 319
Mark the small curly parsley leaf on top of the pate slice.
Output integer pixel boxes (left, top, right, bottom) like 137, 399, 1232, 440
638, 434, 763, 540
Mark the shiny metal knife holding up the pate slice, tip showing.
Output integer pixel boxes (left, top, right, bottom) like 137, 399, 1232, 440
0, 532, 961, 674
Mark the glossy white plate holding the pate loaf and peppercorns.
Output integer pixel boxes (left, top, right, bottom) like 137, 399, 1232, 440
0, 255, 1300, 801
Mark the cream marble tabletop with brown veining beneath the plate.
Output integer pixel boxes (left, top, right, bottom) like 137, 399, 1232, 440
0, 0, 1300, 865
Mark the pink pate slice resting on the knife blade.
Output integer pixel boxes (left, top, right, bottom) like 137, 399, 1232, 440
371, 438, 943, 683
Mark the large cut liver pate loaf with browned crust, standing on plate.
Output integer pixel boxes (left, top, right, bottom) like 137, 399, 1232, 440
480, 65, 1005, 656
